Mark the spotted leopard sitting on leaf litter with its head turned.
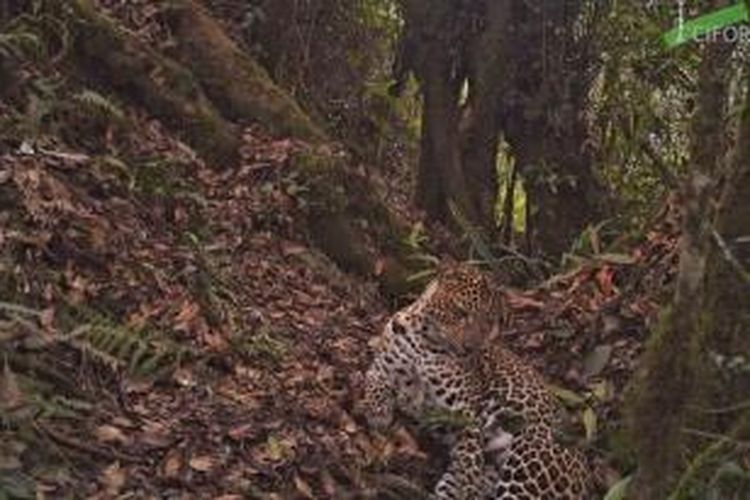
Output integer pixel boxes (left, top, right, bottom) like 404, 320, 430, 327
360, 269, 591, 500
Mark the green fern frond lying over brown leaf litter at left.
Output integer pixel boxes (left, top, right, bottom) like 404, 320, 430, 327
60, 308, 192, 377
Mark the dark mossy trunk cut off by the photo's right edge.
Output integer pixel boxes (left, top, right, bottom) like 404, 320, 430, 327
669, 66, 750, 500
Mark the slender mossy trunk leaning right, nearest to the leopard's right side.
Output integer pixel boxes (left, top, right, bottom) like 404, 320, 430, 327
629, 43, 731, 500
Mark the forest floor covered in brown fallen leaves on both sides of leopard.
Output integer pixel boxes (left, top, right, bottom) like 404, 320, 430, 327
0, 110, 675, 499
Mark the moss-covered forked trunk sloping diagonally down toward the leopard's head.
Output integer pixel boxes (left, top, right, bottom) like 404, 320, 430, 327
62, 0, 420, 294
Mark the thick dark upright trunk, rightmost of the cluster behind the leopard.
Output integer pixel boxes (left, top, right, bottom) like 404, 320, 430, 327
502, 1, 605, 258
